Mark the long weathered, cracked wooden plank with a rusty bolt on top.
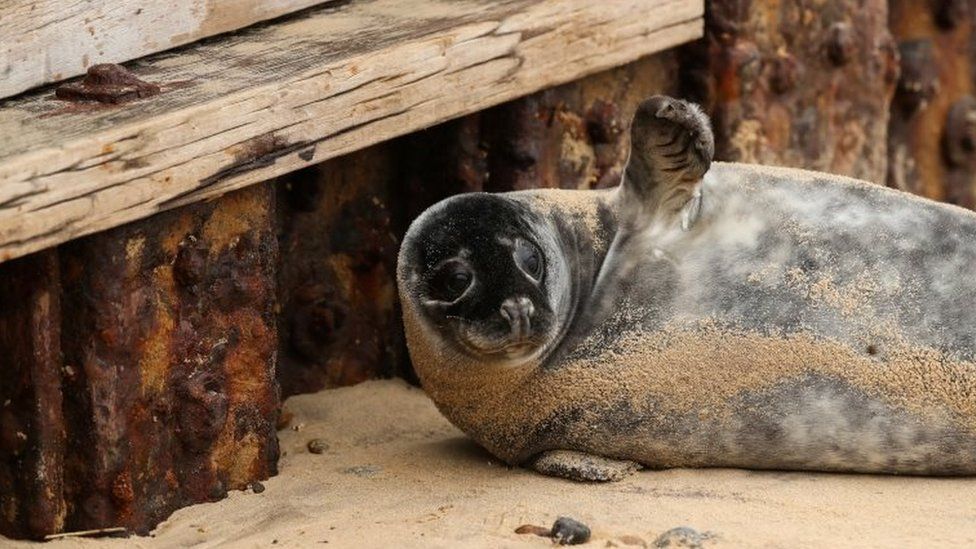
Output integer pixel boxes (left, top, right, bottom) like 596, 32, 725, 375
0, 0, 703, 260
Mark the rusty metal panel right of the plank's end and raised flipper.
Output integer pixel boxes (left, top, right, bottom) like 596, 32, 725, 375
682, 0, 898, 182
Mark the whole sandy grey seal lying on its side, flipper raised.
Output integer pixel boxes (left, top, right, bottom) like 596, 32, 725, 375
397, 96, 976, 481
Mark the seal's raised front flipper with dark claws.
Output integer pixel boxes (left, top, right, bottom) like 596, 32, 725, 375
621, 95, 715, 230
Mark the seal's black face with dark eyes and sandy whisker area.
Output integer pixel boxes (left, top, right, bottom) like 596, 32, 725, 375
400, 193, 567, 362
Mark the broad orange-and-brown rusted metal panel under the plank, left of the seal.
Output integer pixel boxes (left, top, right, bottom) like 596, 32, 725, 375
61, 185, 278, 533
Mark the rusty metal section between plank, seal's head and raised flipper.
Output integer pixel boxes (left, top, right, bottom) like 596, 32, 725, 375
401, 53, 677, 201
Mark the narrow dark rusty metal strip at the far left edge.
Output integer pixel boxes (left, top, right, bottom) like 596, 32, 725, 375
0, 250, 65, 538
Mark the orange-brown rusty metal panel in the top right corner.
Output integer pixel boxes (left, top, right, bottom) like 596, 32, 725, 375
888, 0, 976, 208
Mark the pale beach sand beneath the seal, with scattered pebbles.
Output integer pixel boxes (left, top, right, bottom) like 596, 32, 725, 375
7, 381, 976, 548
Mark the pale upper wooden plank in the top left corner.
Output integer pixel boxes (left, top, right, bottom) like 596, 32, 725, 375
0, 0, 332, 98
